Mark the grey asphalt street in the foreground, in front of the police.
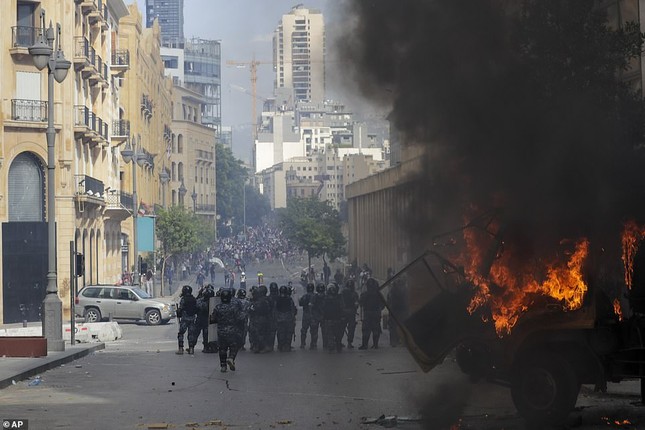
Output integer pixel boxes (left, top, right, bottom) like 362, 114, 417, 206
0, 256, 645, 430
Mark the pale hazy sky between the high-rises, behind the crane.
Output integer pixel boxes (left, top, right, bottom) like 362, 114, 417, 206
126, 0, 339, 161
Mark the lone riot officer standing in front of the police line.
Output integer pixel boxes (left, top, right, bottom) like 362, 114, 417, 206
210, 288, 244, 372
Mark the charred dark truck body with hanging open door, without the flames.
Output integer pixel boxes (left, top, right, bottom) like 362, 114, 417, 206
380, 217, 645, 425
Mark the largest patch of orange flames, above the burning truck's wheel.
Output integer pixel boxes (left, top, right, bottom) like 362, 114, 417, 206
462, 222, 589, 337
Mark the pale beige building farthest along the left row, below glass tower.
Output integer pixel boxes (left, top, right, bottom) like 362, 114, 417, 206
167, 86, 217, 225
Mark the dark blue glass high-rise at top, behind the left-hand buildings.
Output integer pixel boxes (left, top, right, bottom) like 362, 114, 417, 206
146, 0, 184, 47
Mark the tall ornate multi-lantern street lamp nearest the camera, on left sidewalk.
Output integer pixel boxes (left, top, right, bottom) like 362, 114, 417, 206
29, 10, 74, 351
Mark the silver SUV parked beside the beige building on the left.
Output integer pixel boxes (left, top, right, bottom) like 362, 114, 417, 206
75, 285, 176, 325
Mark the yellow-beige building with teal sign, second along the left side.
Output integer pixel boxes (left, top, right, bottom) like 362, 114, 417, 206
115, 3, 172, 284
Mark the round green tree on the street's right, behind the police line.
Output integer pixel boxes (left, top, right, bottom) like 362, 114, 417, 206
277, 198, 345, 266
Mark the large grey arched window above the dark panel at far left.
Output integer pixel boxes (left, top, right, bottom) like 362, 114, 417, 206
9, 152, 45, 222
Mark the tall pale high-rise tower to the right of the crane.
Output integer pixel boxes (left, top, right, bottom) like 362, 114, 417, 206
273, 5, 325, 103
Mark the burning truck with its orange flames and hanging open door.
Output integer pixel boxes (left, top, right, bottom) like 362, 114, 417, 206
381, 212, 645, 425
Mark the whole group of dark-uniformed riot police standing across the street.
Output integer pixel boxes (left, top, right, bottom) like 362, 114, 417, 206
177, 278, 384, 372
